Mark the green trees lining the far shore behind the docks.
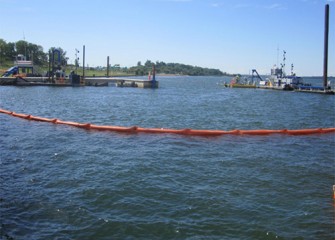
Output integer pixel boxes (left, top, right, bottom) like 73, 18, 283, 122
0, 39, 227, 76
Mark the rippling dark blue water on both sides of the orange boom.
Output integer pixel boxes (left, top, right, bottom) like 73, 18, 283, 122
0, 77, 335, 239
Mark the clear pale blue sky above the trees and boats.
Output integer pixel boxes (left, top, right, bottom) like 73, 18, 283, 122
0, 0, 335, 76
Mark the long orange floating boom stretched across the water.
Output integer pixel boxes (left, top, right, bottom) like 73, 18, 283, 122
0, 109, 335, 137
